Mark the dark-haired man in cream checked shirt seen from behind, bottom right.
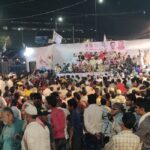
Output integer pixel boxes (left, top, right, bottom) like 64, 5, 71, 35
104, 113, 141, 150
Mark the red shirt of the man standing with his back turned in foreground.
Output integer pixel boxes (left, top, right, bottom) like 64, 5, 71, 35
51, 108, 66, 139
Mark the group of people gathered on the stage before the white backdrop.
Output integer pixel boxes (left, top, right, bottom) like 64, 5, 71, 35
55, 51, 144, 73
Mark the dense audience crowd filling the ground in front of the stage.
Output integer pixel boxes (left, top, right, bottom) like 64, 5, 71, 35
0, 59, 150, 150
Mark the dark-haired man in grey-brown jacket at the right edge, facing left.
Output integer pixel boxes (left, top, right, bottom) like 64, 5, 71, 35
136, 99, 150, 150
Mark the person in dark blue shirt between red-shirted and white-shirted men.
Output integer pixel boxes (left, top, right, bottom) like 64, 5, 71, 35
68, 99, 83, 150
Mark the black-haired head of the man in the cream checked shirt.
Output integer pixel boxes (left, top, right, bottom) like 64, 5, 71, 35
122, 112, 136, 129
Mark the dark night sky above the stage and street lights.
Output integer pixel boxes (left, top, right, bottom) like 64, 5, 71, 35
0, 0, 150, 40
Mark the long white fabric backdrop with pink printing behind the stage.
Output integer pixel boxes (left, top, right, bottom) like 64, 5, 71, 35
26, 39, 150, 71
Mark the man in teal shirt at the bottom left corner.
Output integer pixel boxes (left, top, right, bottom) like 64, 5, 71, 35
0, 107, 24, 150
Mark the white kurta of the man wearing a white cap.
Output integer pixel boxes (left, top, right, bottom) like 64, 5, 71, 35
21, 122, 51, 150
